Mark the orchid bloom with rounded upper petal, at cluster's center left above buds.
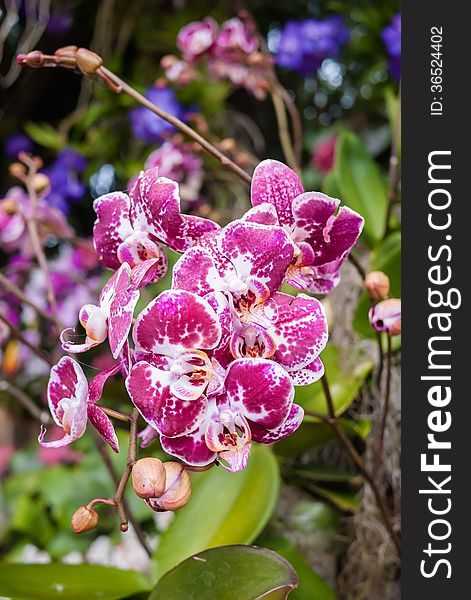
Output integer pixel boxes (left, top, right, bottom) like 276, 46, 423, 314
126, 290, 221, 437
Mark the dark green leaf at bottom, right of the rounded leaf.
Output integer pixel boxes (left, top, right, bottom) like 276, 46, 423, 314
264, 539, 335, 600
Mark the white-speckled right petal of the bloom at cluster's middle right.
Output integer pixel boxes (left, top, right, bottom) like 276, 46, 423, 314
269, 293, 328, 371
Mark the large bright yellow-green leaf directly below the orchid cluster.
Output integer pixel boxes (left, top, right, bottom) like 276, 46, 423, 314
154, 445, 279, 577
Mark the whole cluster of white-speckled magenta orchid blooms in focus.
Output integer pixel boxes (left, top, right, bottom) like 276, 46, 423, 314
40, 160, 363, 488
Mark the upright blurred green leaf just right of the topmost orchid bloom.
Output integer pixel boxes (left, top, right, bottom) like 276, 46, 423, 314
328, 131, 388, 246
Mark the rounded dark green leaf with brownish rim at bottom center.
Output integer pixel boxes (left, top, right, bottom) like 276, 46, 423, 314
149, 545, 298, 600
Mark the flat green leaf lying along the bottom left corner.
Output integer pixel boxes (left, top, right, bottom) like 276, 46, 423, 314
0, 563, 150, 600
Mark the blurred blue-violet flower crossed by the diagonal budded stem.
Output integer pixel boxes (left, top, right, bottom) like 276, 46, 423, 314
129, 87, 185, 144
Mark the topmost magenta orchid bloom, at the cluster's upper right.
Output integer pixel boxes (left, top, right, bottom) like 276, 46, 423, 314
244, 160, 364, 294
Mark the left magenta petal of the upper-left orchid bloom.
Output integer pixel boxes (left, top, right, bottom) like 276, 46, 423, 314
93, 192, 133, 270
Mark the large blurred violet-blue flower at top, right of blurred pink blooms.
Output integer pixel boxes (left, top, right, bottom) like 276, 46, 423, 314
275, 17, 349, 75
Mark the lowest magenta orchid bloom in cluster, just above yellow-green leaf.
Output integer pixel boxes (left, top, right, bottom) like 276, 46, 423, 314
160, 358, 304, 472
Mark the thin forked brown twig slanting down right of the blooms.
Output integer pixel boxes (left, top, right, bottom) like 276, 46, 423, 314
312, 375, 401, 554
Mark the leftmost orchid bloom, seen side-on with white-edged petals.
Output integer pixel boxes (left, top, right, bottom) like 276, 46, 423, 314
38, 356, 120, 452
